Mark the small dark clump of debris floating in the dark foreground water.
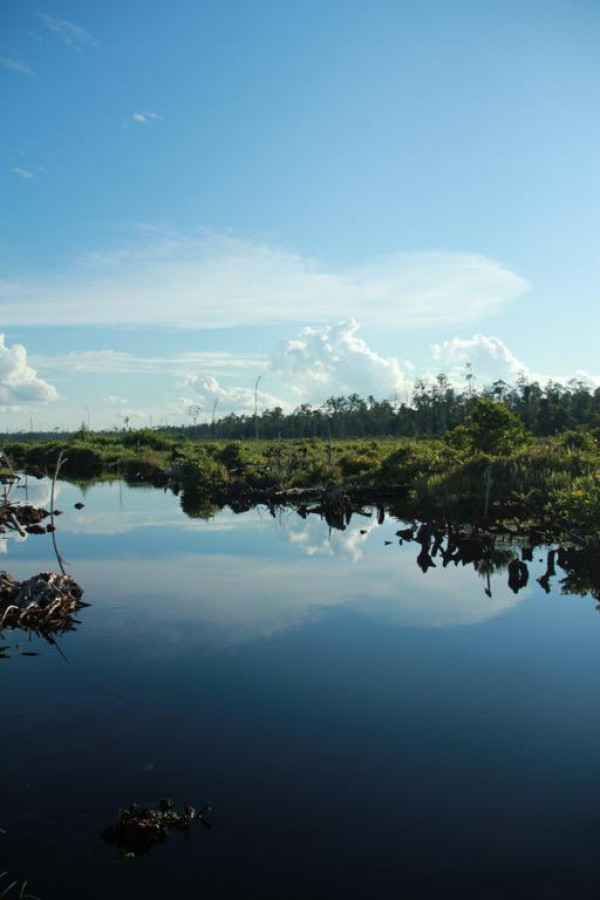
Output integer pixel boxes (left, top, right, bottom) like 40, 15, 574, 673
102, 797, 212, 859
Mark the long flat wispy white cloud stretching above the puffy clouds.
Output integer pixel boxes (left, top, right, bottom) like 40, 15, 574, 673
0, 234, 528, 330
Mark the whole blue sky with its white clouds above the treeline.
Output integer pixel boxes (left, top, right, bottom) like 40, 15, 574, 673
0, 0, 600, 429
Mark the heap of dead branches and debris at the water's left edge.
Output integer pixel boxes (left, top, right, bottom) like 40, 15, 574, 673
0, 572, 89, 637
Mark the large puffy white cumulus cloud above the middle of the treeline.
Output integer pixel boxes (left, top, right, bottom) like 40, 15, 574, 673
270, 319, 407, 400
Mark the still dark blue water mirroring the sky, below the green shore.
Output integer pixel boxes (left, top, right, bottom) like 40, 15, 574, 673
0, 482, 600, 900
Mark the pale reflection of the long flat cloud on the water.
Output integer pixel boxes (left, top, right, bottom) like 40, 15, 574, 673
78, 547, 526, 656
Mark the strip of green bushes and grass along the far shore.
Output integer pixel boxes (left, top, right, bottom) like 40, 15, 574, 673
3, 396, 600, 536
